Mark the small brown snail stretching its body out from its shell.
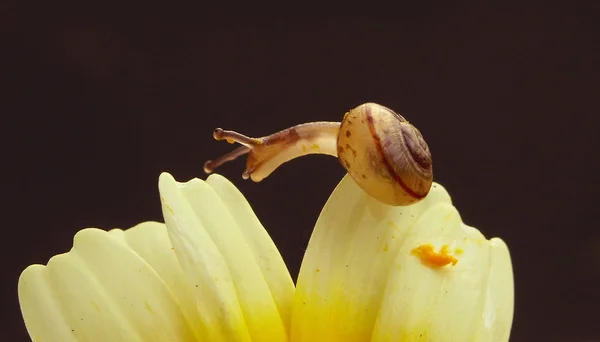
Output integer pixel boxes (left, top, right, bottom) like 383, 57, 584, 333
204, 103, 433, 206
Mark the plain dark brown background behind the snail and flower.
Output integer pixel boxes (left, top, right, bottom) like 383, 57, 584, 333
0, 1, 600, 341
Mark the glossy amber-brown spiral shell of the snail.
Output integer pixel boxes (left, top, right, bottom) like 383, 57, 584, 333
337, 103, 433, 206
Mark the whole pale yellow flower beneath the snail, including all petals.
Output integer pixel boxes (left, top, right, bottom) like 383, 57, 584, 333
19, 174, 514, 342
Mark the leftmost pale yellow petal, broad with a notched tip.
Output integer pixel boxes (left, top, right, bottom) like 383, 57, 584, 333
19, 229, 196, 342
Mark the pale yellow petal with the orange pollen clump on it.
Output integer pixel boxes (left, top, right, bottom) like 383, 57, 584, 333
373, 204, 490, 342
